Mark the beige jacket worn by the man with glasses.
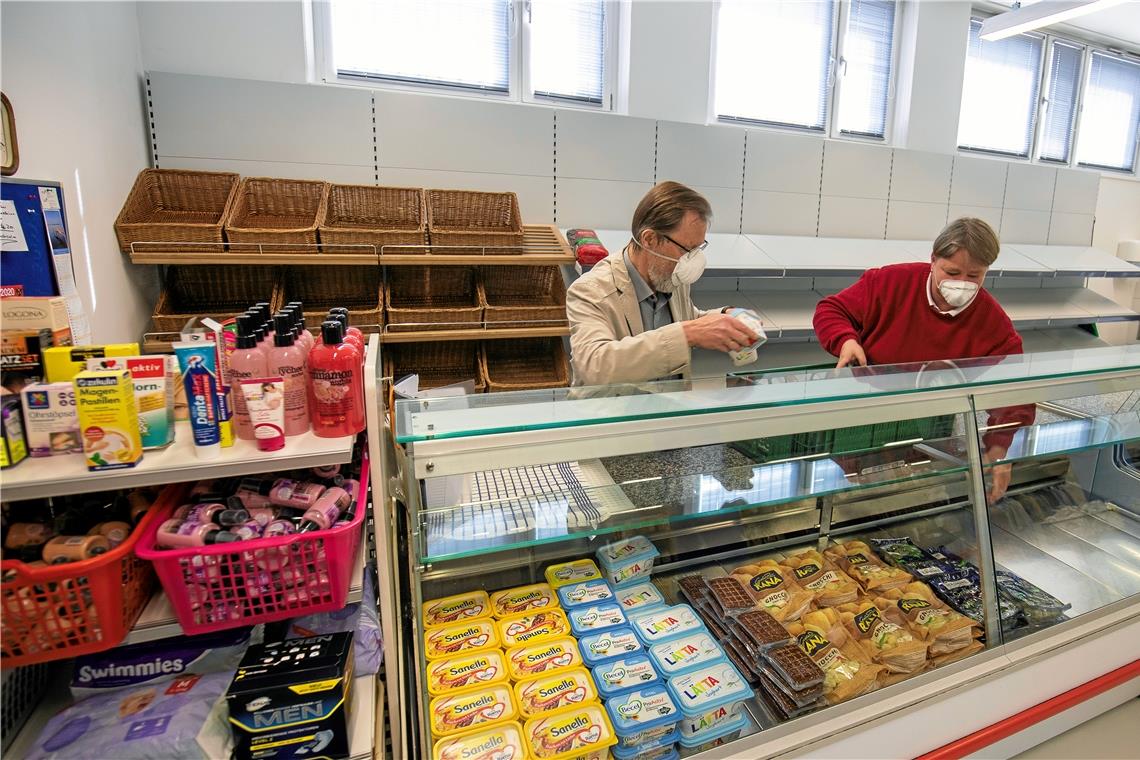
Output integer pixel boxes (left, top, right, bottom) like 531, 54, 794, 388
567, 252, 705, 385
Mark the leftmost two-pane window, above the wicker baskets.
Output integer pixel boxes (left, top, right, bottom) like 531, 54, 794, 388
315, 0, 617, 107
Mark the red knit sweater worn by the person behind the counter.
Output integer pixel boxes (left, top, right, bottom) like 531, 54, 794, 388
814, 263, 1034, 448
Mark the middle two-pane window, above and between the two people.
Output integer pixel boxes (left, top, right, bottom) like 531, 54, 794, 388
715, 0, 896, 138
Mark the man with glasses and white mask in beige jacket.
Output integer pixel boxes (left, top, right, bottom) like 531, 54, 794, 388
567, 182, 758, 385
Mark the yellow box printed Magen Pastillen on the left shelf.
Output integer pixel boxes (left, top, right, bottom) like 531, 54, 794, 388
75, 369, 143, 471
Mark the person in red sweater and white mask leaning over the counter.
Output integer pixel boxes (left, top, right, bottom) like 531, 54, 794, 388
814, 218, 1034, 502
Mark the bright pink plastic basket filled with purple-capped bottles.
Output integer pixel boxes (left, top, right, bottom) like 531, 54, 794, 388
138, 456, 368, 635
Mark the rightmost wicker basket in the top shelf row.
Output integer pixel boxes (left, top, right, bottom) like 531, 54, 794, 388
428, 190, 522, 256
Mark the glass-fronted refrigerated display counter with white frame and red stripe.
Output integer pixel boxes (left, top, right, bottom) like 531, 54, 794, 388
374, 346, 1140, 757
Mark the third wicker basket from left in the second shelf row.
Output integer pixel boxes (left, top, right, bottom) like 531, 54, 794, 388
384, 267, 483, 332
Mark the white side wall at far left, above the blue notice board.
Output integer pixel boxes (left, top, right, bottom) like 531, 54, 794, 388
0, 1, 157, 342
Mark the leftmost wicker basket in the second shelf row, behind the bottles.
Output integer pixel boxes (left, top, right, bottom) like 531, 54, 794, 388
152, 264, 284, 333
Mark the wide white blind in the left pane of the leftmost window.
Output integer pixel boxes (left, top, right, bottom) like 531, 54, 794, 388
329, 0, 511, 92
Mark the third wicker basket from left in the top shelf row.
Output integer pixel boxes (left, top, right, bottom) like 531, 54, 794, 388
318, 185, 428, 256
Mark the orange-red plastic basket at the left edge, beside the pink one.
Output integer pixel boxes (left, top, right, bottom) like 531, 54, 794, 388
0, 504, 161, 668
